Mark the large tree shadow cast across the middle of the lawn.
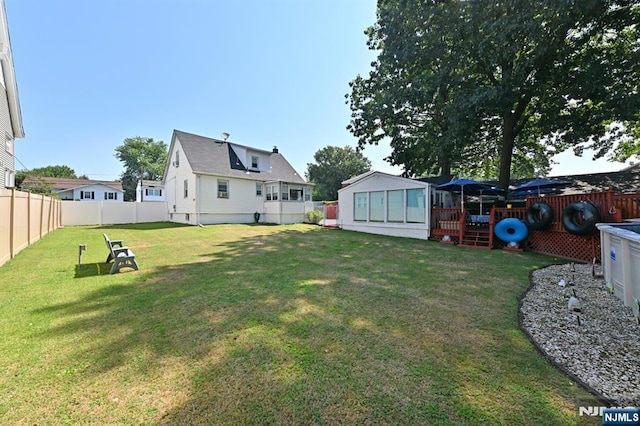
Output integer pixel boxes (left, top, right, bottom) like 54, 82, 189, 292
28, 227, 600, 424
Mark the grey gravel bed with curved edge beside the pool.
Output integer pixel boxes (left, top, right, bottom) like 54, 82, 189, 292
520, 263, 640, 407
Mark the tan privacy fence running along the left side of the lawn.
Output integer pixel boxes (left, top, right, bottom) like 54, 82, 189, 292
0, 189, 61, 266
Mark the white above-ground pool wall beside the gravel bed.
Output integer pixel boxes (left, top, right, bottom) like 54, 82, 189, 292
596, 223, 640, 307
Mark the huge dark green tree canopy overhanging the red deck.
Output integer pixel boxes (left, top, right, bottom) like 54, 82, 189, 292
347, 0, 640, 188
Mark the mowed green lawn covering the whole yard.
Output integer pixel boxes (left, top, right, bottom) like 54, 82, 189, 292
0, 224, 601, 425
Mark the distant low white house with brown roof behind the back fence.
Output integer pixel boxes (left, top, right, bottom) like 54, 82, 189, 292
21, 176, 124, 202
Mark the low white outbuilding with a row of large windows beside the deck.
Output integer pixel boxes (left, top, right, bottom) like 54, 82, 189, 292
338, 171, 435, 240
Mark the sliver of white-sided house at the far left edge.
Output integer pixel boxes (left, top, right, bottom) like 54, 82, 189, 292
0, 0, 24, 189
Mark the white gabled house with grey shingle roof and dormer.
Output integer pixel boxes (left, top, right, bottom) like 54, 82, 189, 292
162, 130, 312, 225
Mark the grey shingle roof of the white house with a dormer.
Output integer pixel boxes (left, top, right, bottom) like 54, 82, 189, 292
167, 130, 307, 184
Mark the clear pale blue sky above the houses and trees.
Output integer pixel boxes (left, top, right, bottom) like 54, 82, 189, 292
5, 0, 636, 180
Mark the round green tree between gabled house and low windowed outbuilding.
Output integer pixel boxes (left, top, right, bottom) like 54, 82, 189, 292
305, 146, 371, 201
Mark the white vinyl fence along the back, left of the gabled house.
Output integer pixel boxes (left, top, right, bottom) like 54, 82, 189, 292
62, 201, 169, 226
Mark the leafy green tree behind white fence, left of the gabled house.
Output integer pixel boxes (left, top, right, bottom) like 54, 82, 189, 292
115, 136, 168, 201
